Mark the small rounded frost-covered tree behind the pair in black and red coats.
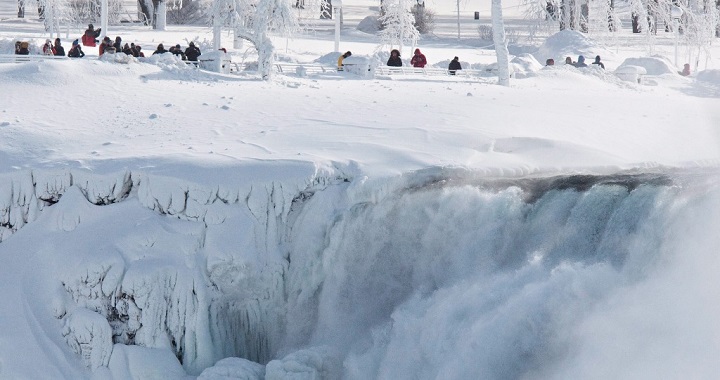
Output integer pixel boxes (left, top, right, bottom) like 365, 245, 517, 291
378, 0, 420, 51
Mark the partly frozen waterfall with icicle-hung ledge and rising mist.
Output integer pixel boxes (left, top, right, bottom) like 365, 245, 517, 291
0, 169, 720, 379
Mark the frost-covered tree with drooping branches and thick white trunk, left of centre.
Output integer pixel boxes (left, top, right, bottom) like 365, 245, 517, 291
213, 0, 298, 80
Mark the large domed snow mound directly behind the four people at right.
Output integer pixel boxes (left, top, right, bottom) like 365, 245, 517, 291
533, 30, 614, 62
